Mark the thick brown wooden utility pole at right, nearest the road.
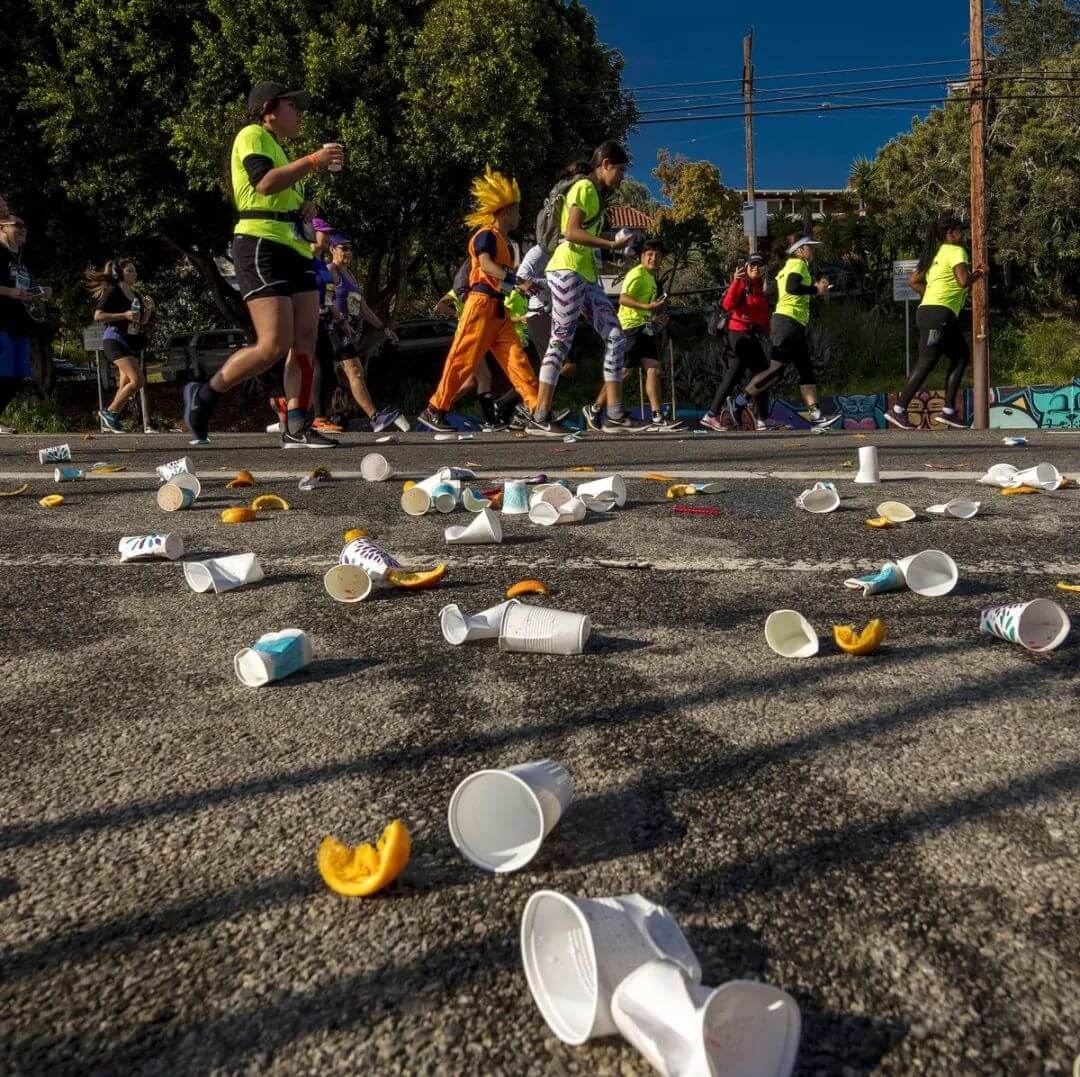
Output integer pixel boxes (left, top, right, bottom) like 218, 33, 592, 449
969, 0, 990, 430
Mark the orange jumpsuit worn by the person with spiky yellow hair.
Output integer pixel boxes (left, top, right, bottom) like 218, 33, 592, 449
428, 225, 540, 412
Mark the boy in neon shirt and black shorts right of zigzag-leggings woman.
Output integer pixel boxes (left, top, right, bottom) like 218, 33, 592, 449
581, 240, 683, 433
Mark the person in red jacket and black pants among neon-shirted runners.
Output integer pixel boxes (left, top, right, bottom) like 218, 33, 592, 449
701, 254, 769, 430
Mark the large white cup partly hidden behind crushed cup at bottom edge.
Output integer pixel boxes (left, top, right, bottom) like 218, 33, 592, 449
522, 890, 701, 1046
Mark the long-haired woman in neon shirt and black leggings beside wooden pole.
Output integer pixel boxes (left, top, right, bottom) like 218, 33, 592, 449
885, 211, 987, 430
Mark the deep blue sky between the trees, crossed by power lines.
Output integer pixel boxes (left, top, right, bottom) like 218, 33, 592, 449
584, 0, 968, 189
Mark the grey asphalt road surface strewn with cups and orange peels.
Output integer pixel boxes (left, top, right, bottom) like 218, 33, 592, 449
0, 431, 1080, 1077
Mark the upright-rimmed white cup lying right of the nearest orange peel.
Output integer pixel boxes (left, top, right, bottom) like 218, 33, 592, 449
447, 759, 573, 875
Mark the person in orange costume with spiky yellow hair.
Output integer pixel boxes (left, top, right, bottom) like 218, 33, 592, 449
418, 167, 538, 432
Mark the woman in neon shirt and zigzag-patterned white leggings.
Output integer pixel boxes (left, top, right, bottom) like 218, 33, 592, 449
527, 142, 645, 433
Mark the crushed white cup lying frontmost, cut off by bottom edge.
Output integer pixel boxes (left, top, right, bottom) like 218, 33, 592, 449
611, 960, 801, 1077
